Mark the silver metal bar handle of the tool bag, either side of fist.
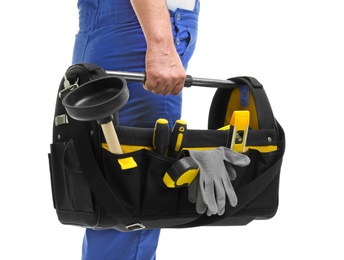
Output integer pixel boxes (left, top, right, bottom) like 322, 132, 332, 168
106, 70, 237, 88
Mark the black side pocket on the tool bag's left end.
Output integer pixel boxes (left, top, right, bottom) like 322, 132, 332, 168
49, 140, 98, 226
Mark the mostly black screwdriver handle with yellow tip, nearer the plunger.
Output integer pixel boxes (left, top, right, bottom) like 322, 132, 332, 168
153, 118, 170, 155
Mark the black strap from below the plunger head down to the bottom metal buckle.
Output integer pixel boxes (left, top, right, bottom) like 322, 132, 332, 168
69, 118, 144, 230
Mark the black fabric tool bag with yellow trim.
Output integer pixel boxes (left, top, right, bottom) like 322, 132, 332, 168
49, 63, 285, 231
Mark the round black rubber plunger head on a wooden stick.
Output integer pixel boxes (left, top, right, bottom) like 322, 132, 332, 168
62, 76, 129, 124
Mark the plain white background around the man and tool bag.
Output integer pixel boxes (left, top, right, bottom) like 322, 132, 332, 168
0, 0, 344, 260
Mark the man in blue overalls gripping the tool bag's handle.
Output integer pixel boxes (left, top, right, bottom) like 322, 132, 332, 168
73, 0, 199, 260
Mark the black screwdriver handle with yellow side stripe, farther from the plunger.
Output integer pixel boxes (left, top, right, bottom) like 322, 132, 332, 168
169, 119, 187, 159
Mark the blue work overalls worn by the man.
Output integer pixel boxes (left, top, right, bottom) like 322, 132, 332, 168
73, 0, 200, 260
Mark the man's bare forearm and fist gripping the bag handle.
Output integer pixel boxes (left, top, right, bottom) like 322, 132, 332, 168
130, 0, 186, 95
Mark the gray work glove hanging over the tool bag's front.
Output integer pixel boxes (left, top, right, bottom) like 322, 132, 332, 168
189, 146, 250, 216
